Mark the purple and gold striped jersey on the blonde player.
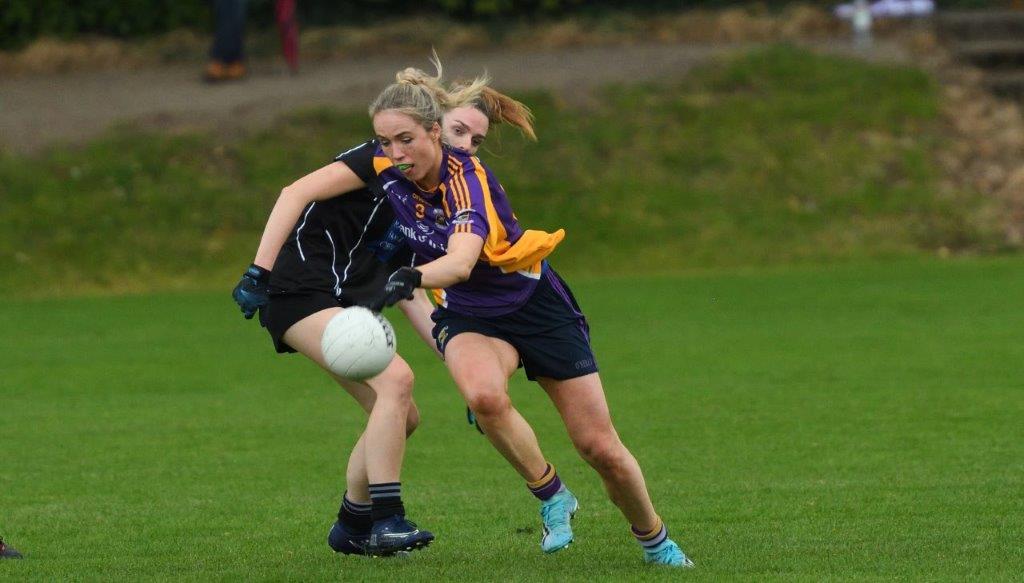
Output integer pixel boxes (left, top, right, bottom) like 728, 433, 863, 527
374, 147, 565, 317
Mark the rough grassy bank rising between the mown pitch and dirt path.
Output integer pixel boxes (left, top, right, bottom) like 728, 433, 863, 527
0, 47, 988, 295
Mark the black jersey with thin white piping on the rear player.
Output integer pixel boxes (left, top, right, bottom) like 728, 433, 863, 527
270, 140, 413, 304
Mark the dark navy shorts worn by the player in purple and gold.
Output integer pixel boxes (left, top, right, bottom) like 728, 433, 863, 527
431, 267, 597, 380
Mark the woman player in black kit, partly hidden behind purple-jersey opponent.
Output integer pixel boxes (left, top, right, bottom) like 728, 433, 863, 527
233, 80, 532, 555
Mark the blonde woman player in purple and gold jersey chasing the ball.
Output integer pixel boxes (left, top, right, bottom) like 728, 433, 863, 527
364, 60, 692, 567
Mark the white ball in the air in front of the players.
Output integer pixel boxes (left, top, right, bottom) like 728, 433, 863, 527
321, 306, 395, 380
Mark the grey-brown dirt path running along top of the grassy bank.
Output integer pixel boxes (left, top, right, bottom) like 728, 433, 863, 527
0, 42, 906, 153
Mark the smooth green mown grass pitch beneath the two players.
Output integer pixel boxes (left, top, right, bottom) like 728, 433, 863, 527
0, 258, 1024, 581
